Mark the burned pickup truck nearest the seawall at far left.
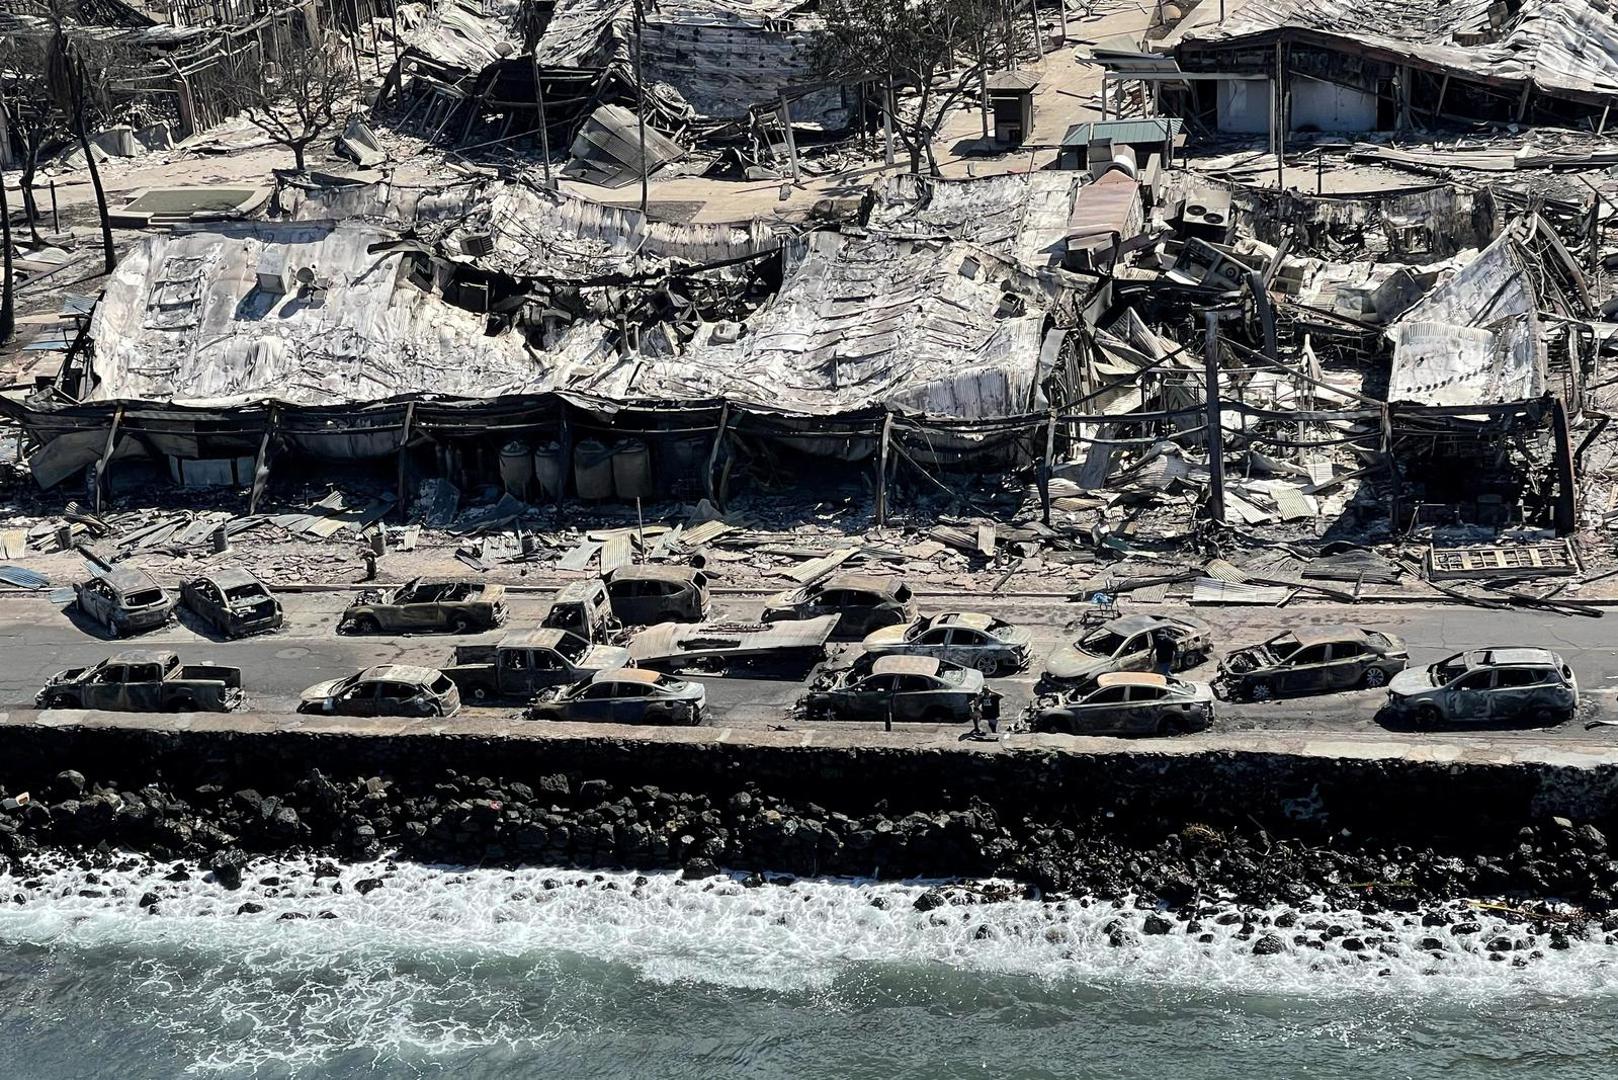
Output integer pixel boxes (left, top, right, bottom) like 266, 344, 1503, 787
34, 653, 243, 712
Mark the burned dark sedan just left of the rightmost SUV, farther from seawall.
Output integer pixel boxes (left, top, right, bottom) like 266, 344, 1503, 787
1215, 627, 1409, 701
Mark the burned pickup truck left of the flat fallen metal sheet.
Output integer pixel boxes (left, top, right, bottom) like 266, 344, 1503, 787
443, 628, 634, 701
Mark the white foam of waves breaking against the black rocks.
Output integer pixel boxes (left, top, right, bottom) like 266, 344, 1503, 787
0, 861, 1618, 1072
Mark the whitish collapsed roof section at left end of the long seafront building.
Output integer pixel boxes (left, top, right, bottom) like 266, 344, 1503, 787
84, 222, 588, 405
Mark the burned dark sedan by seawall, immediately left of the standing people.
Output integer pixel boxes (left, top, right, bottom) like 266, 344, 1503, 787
803, 656, 1000, 724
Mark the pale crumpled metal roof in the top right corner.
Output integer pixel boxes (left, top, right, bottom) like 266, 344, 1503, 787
1184, 0, 1618, 100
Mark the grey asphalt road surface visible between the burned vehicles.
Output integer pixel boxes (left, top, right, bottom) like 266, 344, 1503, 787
0, 593, 1618, 737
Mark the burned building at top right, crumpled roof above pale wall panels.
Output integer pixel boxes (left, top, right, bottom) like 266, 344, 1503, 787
1165, 0, 1618, 134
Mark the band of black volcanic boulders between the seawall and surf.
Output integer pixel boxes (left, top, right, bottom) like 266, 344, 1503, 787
0, 769, 1618, 954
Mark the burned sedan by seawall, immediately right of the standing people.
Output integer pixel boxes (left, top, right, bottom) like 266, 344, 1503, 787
1029, 672, 1214, 735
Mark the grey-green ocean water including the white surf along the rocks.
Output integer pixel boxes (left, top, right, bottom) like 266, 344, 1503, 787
0, 863, 1618, 1080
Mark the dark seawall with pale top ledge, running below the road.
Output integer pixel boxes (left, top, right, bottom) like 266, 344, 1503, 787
0, 712, 1618, 845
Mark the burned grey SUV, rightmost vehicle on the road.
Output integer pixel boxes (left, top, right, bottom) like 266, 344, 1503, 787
1388, 648, 1579, 727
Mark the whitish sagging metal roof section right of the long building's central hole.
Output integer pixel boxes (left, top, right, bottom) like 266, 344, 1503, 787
600, 232, 1058, 418
